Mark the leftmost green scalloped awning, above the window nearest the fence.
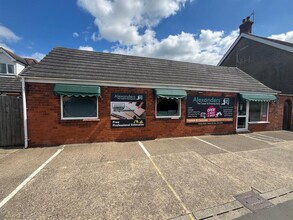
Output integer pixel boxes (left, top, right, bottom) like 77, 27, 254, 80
54, 84, 101, 97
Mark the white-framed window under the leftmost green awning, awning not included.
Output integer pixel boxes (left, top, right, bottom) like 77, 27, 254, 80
61, 96, 98, 120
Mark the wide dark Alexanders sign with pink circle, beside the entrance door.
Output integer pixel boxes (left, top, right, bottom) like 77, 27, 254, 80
186, 96, 234, 125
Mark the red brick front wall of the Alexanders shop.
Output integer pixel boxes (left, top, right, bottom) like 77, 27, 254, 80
26, 83, 282, 146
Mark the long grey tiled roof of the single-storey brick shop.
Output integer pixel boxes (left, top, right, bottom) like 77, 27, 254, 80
20, 47, 276, 93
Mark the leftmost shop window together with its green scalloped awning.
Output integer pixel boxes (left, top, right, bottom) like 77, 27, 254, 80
54, 84, 100, 120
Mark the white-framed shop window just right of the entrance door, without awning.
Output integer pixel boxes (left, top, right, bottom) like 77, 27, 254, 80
249, 102, 269, 122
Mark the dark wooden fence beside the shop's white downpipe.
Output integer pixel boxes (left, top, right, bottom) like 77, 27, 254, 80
0, 96, 24, 147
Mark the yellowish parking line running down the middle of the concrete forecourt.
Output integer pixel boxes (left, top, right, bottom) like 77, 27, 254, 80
138, 141, 194, 220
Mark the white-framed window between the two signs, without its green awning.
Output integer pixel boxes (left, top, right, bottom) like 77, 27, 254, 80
156, 97, 181, 118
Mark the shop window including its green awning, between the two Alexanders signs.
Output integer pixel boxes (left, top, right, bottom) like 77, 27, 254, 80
154, 89, 187, 119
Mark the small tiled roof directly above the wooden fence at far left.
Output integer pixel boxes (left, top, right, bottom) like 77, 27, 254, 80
0, 76, 21, 93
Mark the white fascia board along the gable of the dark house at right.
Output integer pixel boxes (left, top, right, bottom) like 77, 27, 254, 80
217, 33, 293, 66
